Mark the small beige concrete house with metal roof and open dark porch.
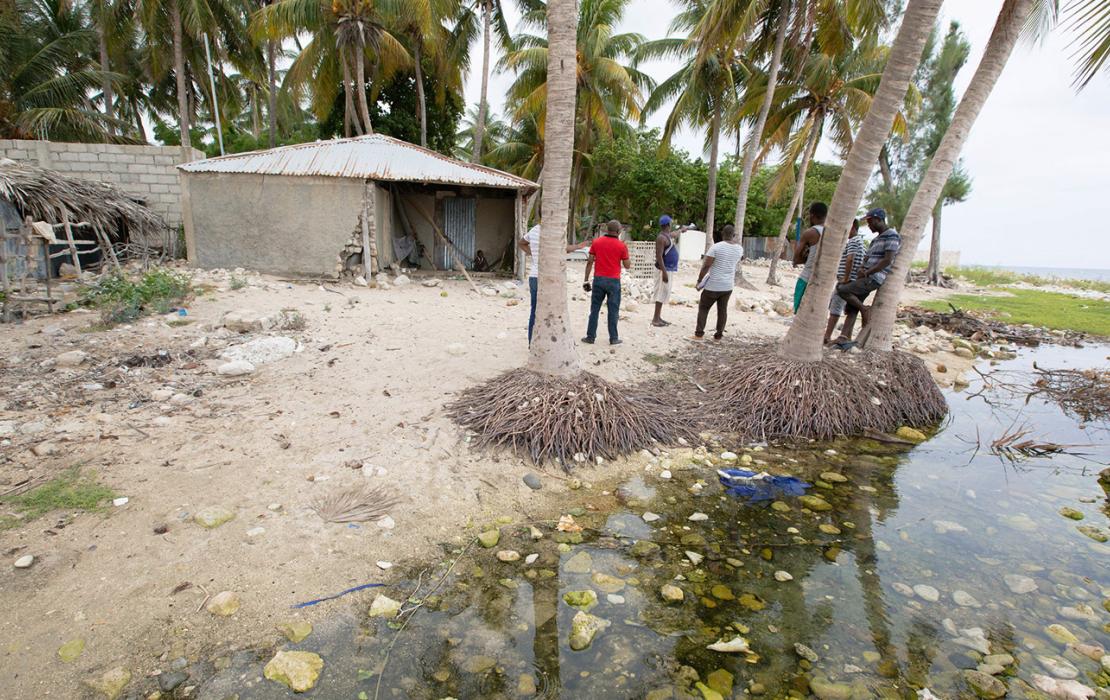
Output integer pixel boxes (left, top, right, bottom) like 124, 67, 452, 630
178, 134, 537, 277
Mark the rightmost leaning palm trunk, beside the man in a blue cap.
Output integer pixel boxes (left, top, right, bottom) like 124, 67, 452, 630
861, 0, 1033, 351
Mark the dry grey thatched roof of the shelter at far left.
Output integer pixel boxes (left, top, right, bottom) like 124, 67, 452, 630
0, 159, 168, 241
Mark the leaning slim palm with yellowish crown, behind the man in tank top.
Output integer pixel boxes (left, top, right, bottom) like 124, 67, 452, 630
763, 42, 901, 285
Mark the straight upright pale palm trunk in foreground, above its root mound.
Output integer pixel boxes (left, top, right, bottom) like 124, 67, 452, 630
527, 0, 582, 376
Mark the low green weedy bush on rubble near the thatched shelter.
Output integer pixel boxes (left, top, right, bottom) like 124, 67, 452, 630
79, 267, 190, 327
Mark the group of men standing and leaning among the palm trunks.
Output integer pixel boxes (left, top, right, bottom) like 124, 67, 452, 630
518, 202, 901, 347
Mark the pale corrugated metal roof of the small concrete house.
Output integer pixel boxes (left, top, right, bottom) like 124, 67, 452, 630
178, 134, 537, 190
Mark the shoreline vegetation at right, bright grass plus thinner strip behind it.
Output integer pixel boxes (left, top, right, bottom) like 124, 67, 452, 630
920, 267, 1110, 338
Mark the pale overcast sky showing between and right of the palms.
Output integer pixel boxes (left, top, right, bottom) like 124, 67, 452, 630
466, 0, 1110, 268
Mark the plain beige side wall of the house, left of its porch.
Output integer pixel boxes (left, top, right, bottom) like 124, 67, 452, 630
183, 173, 363, 277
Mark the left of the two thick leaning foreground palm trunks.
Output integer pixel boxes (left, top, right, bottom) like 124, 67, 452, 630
781, 0, 941, 362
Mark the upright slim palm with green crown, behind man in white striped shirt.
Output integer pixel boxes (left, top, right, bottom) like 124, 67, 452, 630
637, 0, 740, 249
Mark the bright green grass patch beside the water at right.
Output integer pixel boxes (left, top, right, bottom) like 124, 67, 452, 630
921, 290, 1110, 336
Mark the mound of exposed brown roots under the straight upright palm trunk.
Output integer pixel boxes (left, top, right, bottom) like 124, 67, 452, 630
447, 368, 694, 469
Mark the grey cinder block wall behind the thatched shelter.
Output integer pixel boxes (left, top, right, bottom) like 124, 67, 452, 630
0, 139, 204, 229
